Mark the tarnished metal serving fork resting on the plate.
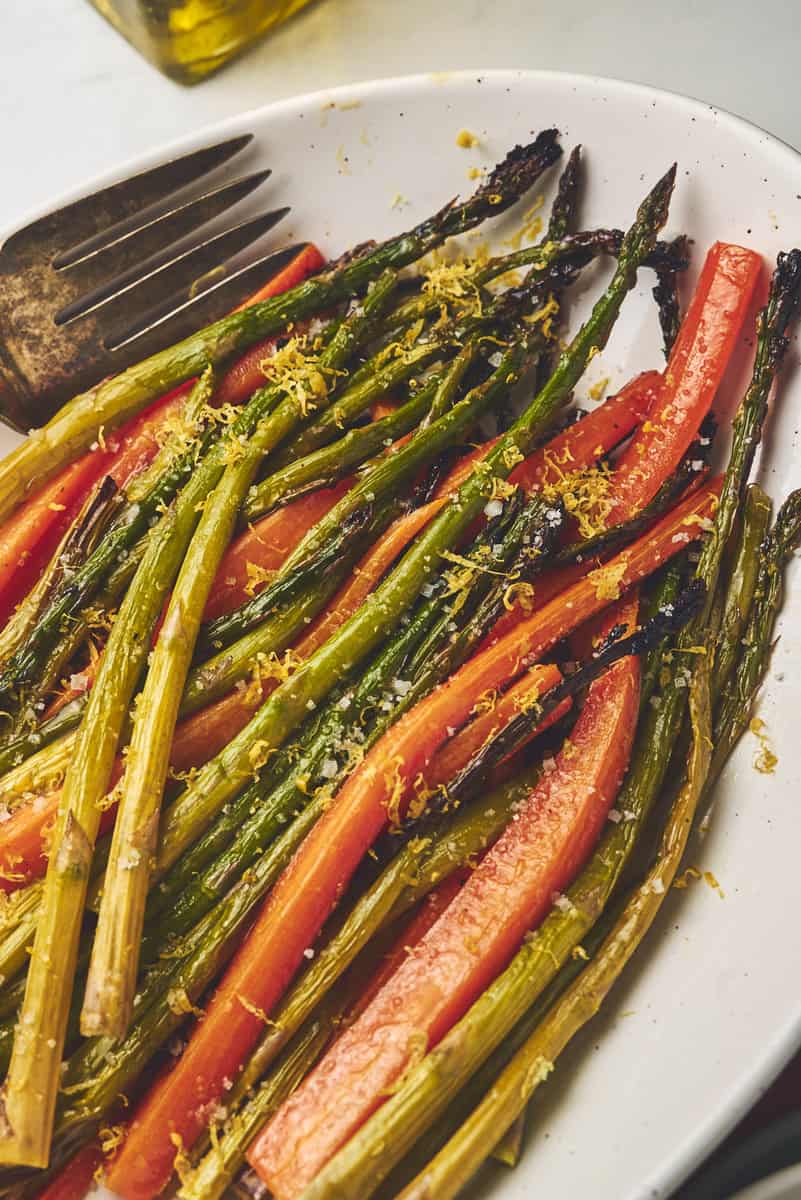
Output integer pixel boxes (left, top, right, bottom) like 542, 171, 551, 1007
0, 133, 300, 430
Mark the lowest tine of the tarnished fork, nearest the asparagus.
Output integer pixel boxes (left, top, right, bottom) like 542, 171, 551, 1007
104, 242, 307, 352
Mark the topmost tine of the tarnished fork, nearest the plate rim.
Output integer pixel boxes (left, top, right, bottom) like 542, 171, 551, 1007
4, 133, 253, 259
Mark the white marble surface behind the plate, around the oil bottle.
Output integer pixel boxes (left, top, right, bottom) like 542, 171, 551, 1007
0, 0, 801, 227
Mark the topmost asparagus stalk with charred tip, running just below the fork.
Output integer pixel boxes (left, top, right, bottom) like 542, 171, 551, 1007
0, 130, 561, 520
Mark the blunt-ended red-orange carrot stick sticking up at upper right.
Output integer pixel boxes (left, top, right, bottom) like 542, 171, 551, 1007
609, 241, 761, 523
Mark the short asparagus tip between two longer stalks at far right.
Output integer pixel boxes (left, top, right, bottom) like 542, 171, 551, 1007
712, 484, 773, 702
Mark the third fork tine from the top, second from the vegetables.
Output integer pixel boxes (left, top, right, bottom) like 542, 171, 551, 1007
54, 208, 289, 326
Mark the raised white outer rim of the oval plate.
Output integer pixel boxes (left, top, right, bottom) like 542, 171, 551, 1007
6, 67, 801, 1196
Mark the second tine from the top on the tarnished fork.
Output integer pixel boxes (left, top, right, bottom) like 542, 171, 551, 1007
53, 169, 272, 274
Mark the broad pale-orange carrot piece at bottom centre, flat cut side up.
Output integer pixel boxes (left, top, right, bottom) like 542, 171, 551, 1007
248, 601, 639, 1200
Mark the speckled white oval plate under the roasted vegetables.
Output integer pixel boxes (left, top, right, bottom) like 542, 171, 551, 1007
0, 72, 801, 1200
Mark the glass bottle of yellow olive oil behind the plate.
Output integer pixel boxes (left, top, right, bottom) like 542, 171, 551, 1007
92, 0, 309, 83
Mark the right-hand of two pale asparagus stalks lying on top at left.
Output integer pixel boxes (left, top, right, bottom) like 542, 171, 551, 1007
80, 265, 396, 1038
